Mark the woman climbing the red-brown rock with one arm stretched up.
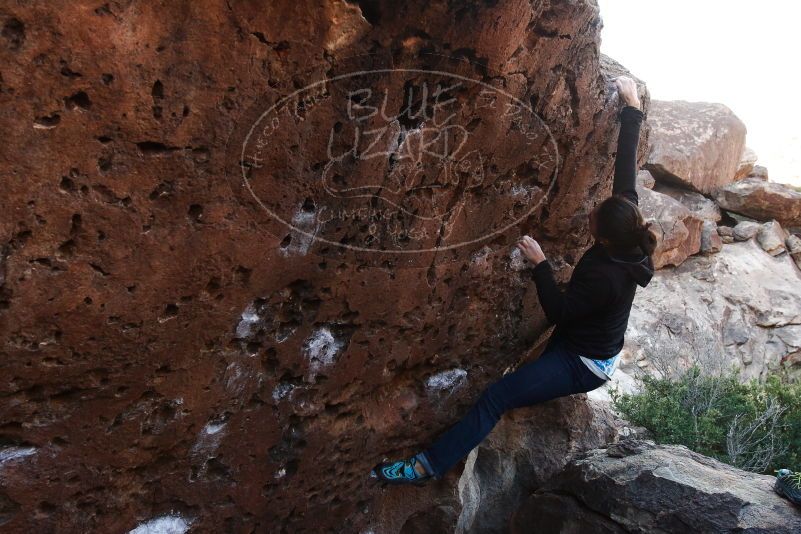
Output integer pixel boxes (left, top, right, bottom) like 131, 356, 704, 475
370, 76, 656, 485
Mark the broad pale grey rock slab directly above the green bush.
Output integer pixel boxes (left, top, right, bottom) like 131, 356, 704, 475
620, 239, 801, 379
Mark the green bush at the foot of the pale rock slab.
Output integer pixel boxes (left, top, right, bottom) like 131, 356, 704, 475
611, 366, 801, 474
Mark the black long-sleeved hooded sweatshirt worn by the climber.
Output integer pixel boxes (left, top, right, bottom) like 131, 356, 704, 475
531, 106, 654, 360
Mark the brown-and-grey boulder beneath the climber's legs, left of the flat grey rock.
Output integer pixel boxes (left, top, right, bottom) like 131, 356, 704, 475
369, 394, 642, 534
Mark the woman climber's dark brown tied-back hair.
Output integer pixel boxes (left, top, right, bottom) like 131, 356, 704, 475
596, 194, 656, 256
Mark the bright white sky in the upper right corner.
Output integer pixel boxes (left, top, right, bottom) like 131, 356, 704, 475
598, 0, 801, 186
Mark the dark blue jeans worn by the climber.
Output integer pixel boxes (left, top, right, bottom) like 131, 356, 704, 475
418, 336, 606, 480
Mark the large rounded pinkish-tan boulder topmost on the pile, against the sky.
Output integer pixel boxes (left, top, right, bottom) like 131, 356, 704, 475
646, 100, 746, 194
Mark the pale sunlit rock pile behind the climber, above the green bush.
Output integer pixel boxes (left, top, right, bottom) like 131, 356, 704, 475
620, 95, 801, 390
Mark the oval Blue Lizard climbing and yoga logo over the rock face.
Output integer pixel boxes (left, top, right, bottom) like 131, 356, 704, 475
239, 69, 559, 254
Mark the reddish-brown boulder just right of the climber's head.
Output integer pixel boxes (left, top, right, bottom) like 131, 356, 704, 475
637, 186, 704, 269
